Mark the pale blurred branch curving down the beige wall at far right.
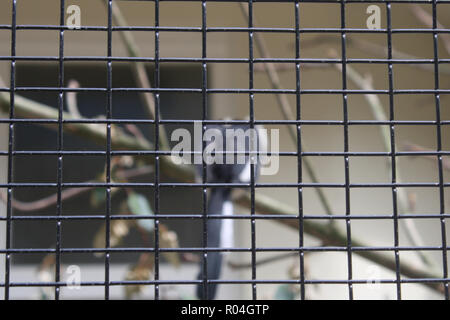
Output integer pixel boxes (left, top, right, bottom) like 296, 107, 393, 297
331, 51, 434, 266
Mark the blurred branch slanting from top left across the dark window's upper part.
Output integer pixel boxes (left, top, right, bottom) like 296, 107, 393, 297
102, 0, 169, 149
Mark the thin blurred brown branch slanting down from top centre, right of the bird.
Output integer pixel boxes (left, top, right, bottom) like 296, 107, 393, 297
240, 2, 333, 215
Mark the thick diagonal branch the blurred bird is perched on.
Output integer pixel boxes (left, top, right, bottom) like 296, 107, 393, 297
0, 79, 443, 293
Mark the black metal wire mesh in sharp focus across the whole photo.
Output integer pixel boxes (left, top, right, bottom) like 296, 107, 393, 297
0, 0, 450, 300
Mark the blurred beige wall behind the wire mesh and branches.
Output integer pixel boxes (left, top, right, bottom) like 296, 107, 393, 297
0, 0, 450, 298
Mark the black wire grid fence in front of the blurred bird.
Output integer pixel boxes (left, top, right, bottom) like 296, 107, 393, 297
0, 0, 450, 300
